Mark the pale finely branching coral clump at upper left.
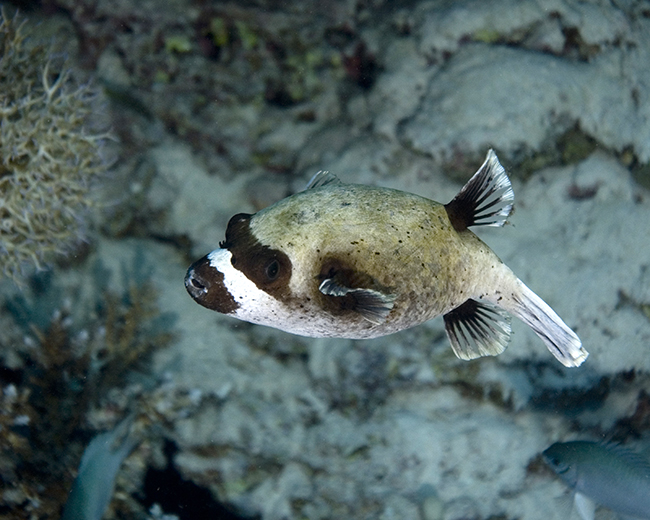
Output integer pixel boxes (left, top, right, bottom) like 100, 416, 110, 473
0, 10, 107, 281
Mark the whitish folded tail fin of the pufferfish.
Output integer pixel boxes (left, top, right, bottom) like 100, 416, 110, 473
508, 280, 589, 367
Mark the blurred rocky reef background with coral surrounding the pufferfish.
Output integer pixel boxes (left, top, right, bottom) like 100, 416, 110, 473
0, 0, 650, 520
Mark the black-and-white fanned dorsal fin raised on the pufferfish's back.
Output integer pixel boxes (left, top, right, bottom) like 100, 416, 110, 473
445, 149, 515, 231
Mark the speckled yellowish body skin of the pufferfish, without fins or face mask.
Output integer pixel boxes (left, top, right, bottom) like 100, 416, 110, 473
243, 184, 519, 339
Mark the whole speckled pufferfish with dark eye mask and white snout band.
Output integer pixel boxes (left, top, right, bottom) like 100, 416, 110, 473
185, 150, 588, 367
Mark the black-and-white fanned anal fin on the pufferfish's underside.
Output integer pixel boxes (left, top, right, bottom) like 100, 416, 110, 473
444, 299, 511, 360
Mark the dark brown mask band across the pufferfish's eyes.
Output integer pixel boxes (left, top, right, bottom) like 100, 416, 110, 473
220, 213, 291, 299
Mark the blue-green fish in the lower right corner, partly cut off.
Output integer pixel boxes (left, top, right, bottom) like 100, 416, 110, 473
542, 441, 650, 520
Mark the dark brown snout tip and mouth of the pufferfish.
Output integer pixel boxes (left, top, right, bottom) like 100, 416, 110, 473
185, 255, 239, 314
